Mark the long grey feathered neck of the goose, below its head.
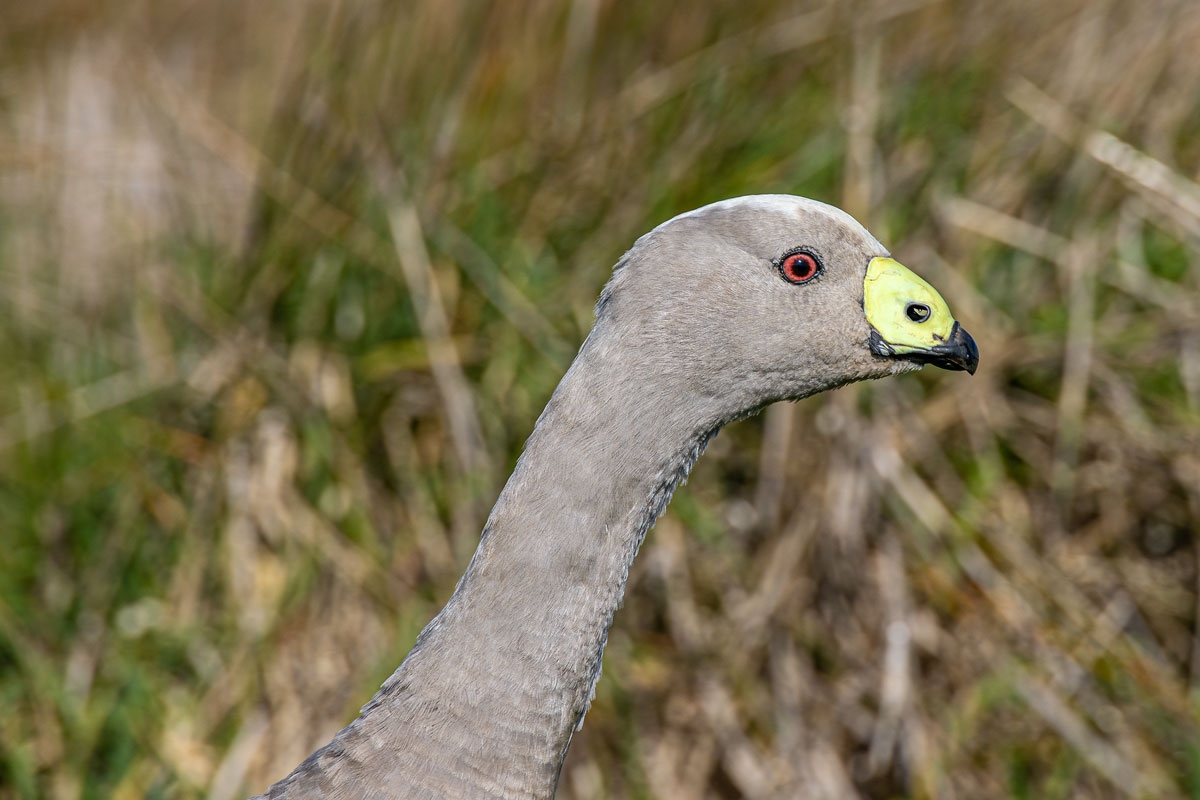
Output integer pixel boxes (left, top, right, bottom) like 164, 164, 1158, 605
272, 329, 724, 798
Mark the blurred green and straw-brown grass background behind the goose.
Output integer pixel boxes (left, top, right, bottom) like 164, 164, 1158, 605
0, 0, 1200, 800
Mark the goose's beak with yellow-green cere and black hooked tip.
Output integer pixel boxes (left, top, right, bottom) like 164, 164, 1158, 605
863, 257, 979, 375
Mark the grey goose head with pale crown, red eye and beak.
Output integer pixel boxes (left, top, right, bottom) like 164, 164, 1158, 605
594, 194, 979, 421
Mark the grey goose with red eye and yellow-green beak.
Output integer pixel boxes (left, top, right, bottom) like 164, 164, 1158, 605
258, 194, 979, 799
